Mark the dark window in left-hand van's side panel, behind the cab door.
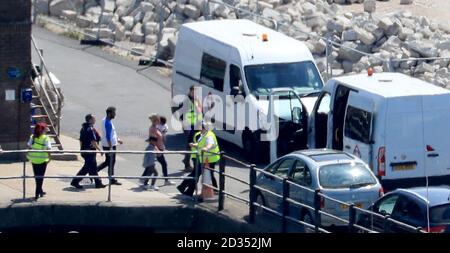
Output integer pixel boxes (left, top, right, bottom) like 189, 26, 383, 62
200, 53, 227, 91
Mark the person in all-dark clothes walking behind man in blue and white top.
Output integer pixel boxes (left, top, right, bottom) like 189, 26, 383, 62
70, 114, 106, 189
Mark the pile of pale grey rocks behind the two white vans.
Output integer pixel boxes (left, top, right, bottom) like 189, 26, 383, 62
36, 0, 450, 86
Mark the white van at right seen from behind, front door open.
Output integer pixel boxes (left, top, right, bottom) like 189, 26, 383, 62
308, 73, 450, 189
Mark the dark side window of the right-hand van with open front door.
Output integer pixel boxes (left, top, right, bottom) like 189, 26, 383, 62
344, 105, 372, 144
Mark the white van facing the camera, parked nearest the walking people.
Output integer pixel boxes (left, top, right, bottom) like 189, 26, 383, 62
172, 20, 323, 161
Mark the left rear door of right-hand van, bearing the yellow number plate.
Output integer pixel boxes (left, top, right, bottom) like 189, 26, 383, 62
383, 96, 425, 179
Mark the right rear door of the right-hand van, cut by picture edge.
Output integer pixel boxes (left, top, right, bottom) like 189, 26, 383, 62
423, 94, 450, 176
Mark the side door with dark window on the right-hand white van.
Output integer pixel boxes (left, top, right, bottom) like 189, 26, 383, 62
344, 91, 374, 166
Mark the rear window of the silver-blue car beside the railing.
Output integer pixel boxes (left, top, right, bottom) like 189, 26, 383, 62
319, 163, 377, 189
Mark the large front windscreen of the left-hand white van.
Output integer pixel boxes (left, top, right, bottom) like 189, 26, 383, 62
245, 61, 323, 96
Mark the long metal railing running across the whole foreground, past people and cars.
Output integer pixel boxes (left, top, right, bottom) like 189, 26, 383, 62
0, 150, 426, 233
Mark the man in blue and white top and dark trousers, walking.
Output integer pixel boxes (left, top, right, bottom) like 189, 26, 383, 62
97, 106, 123, 185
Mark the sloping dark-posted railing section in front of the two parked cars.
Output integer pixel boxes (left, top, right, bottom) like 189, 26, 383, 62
203, 152, 426, 233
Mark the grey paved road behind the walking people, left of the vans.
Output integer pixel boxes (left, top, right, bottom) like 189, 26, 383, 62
33, 27, 253, 202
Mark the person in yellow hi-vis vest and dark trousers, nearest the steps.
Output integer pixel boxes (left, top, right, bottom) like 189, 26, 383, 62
27, 123, 52, 200
